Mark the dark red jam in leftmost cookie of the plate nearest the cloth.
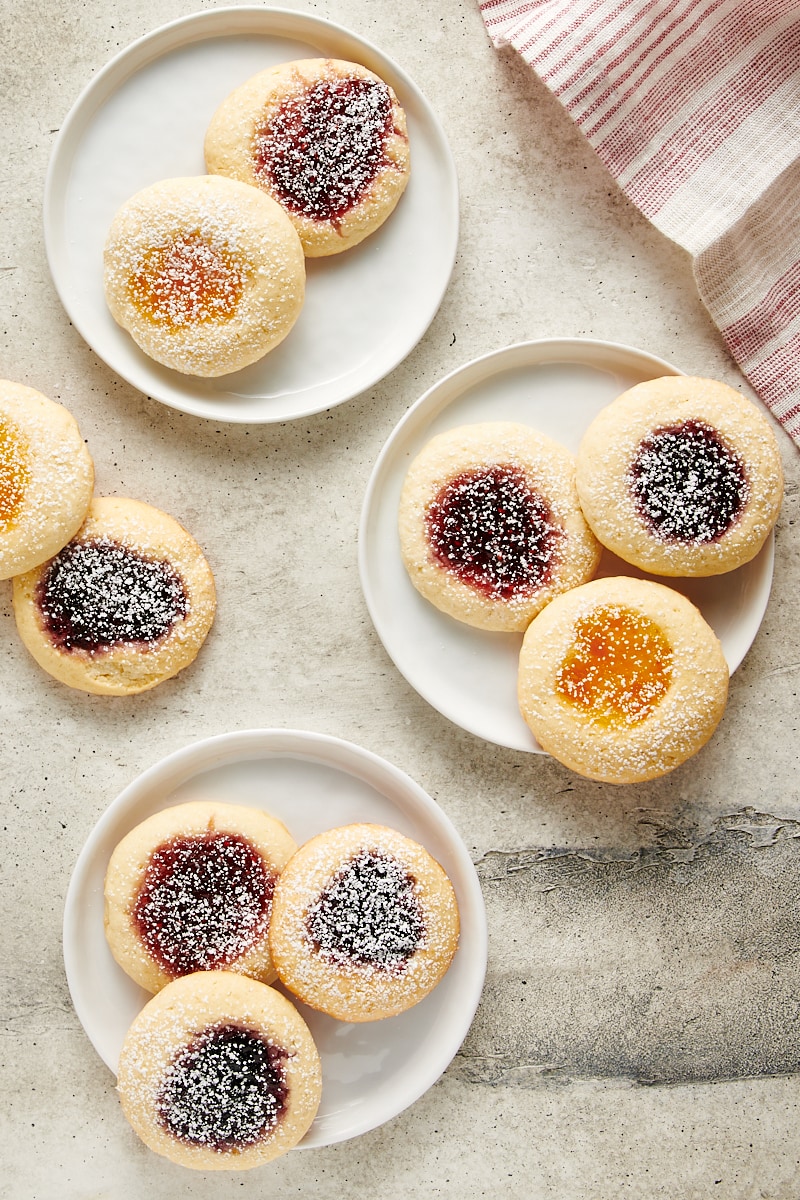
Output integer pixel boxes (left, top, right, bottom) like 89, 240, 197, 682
426, 464, 563, 600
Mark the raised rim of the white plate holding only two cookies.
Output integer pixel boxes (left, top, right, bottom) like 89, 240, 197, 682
42, 5, 459, 425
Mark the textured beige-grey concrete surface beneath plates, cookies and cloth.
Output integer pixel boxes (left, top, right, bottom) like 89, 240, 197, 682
0, 0, 800, 1200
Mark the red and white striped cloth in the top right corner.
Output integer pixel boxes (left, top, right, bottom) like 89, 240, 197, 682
479, 0, 800, 445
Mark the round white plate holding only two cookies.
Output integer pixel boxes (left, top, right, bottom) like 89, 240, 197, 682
44, 7, 458, 422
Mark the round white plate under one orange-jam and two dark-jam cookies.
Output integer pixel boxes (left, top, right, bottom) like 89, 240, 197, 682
359, 338, 774, 754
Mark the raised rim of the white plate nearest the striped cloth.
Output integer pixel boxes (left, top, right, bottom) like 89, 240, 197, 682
357, 336, 775, 755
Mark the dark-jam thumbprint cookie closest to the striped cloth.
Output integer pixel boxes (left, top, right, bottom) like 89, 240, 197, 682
577, 376, 783, 576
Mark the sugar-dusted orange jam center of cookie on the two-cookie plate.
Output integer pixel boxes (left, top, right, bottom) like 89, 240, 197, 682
128, 233, 245, 328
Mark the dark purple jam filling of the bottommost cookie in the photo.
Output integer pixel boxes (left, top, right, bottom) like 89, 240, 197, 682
156, 1025, 288, 1152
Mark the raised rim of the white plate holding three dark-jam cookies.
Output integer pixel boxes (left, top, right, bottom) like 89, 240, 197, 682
61, 727, 488, 1150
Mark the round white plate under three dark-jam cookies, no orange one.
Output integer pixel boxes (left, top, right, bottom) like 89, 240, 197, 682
64, 730, 487, 1147
